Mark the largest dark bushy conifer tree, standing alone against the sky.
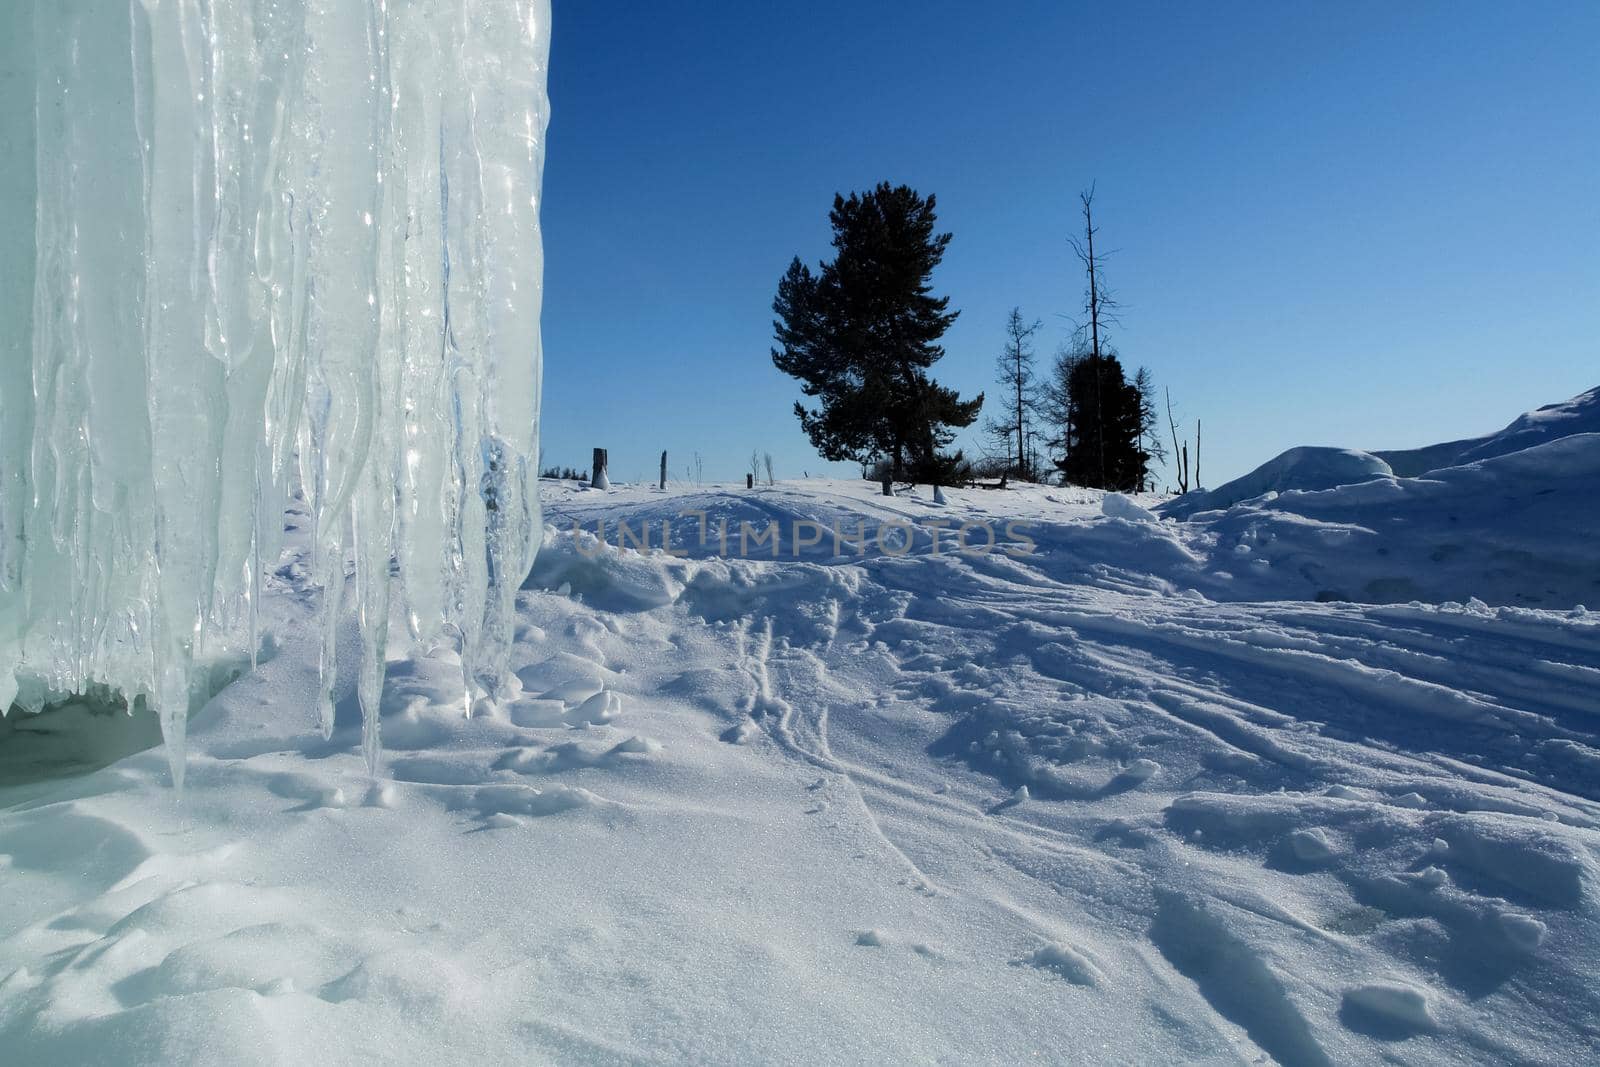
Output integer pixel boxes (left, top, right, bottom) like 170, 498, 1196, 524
773, 182, 984, 485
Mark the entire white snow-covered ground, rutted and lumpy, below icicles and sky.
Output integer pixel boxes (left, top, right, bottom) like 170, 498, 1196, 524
9, 403, 1600, 1064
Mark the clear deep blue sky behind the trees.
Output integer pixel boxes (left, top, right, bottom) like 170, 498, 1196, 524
544, 0, 1600, 485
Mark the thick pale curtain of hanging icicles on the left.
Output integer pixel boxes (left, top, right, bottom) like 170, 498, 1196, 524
0, 0, 550, 785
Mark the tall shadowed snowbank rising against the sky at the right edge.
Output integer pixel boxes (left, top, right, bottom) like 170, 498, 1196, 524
1147, 389, 1600, 608
